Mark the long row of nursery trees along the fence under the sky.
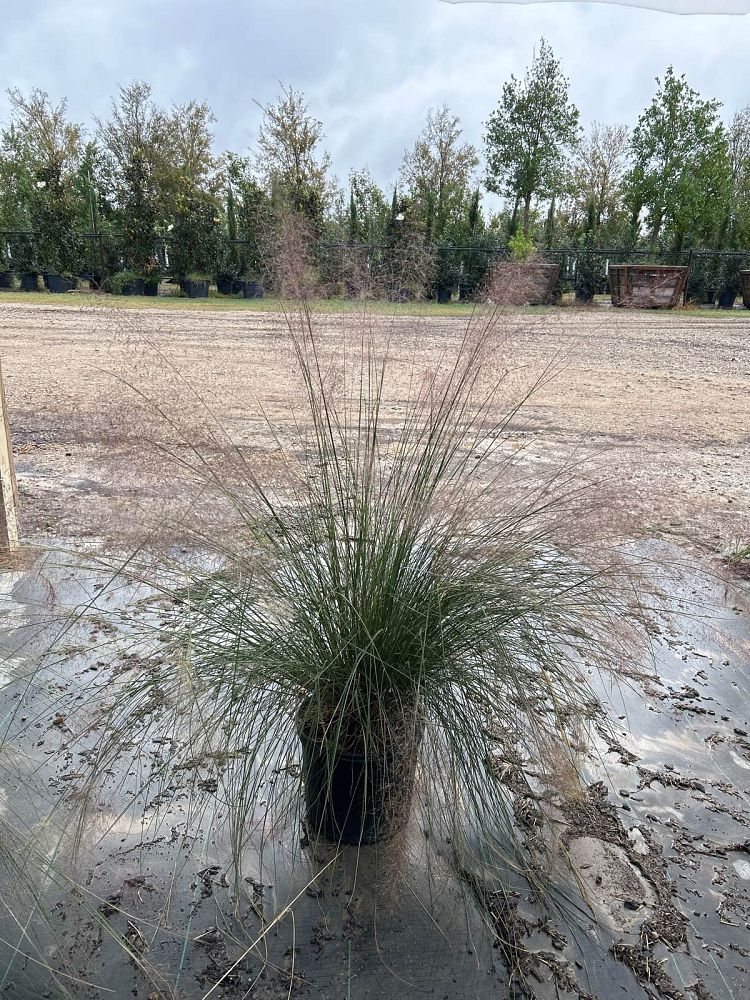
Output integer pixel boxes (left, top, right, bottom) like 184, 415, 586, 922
0, 40, 750, 288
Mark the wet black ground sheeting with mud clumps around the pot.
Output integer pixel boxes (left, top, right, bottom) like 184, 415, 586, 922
0, 545, 750, 1000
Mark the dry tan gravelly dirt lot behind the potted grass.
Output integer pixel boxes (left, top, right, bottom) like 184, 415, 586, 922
0, 303, 750, 551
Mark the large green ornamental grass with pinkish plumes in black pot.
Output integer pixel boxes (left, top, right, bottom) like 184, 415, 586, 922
88, 302, 639, 865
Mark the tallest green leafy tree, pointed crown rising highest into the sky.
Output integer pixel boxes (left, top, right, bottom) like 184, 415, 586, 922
485, 39, 578, 236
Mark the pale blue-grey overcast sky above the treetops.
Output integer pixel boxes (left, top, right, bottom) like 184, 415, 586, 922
0, 0, 750, 193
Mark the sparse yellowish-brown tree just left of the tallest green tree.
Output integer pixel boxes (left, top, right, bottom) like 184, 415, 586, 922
400, 104, 479, 239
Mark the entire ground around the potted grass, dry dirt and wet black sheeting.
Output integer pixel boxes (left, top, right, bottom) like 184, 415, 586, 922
0, 303, 750, 1000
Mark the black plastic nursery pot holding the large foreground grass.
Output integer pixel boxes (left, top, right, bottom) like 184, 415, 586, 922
299, 729, 416, 844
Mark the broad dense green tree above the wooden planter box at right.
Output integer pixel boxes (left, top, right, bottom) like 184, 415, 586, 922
627, 66, 730, 249
